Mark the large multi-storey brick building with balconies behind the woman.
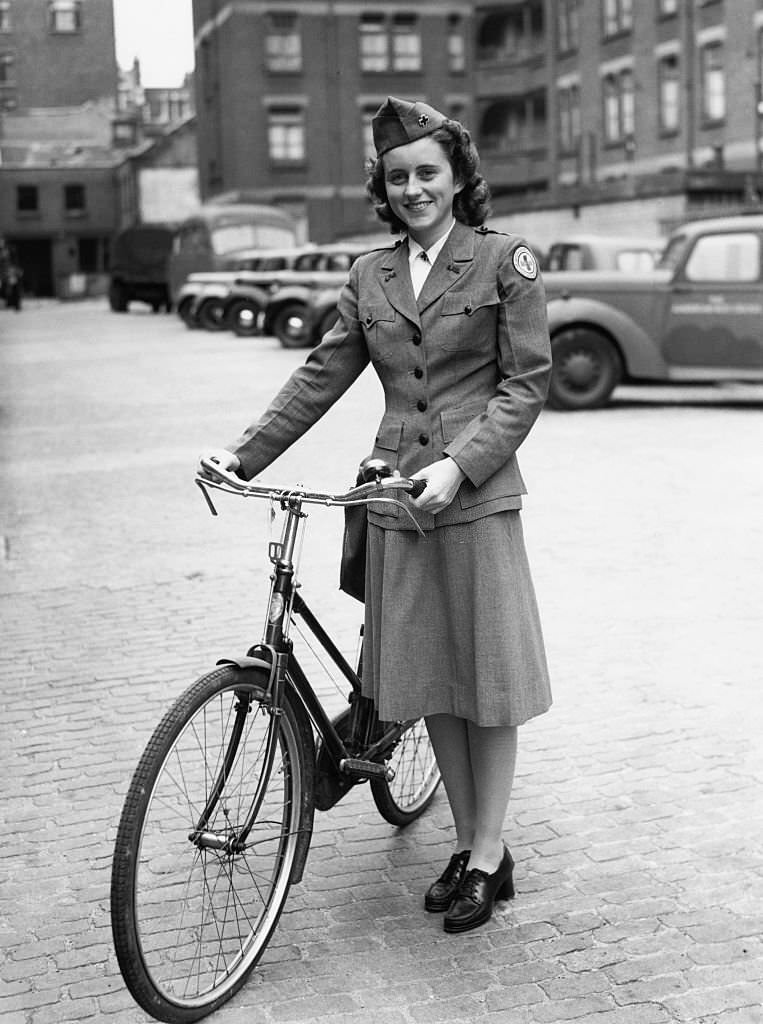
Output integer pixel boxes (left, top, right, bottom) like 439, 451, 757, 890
194, 0, 763, 242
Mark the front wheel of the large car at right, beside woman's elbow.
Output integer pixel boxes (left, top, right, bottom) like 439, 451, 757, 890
548, 328, 623, 410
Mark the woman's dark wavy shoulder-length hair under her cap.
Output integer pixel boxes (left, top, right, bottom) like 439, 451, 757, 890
366, 119, 491, 233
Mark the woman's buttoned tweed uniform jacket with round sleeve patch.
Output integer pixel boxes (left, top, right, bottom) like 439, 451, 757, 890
229, 221, 551, 529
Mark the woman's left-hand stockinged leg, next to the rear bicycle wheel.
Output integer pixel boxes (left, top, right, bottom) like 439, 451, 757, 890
424, 715, 476, 853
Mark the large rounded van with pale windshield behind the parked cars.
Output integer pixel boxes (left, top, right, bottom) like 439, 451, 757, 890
169, 202, 297, 305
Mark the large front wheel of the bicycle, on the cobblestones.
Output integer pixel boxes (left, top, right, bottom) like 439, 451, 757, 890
112, 666, 314, 1024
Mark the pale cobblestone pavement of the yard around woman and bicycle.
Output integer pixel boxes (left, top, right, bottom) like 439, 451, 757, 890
0, 302, 763, 1024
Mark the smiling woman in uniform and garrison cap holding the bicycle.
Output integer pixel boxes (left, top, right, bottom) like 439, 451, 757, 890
199, 97, 551, 932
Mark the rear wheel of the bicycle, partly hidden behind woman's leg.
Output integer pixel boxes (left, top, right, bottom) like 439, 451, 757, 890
371, 718, 440, 827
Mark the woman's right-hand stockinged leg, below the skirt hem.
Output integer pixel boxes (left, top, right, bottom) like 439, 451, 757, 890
464, 722, 517, 874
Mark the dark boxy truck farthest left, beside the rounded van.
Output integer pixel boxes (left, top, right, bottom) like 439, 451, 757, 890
109, 223, 175, 313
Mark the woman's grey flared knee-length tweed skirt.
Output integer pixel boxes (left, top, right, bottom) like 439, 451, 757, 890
363, 511, 551, 726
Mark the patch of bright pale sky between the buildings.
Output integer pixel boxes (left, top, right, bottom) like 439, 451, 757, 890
114, 0, 194, 88
